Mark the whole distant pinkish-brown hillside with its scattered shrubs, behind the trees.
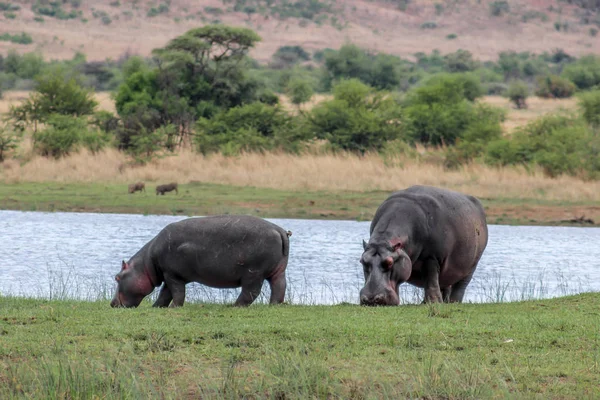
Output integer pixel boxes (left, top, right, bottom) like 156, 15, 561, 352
0, 0, 600, 61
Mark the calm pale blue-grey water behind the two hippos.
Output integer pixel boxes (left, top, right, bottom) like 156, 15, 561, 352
0, 211, 600, 304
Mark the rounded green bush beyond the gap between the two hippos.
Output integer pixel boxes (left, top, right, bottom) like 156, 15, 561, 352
305, 79, 403, 153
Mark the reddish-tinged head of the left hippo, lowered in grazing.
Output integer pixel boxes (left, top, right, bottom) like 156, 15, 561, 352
110, 261, 154, 307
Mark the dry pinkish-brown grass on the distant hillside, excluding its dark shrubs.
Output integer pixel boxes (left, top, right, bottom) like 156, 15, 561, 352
0, 0, 600, 61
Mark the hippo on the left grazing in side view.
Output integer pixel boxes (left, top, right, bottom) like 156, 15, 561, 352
110, 215, 292, 307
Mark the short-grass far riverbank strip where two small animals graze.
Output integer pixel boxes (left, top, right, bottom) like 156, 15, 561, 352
0, 182, 600, 226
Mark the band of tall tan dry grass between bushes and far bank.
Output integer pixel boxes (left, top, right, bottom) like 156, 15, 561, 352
0, 150, 600, 201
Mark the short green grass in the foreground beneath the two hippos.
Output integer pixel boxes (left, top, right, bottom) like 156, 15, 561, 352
0, 293, 600, 399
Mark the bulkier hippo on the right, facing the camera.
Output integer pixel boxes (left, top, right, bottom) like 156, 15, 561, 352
360, 186, 488, 305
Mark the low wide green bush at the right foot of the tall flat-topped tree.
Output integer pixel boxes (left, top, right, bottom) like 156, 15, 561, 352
195, 102, 299, 155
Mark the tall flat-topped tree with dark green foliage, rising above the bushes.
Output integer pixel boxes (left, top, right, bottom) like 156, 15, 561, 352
116, 25, 262, 143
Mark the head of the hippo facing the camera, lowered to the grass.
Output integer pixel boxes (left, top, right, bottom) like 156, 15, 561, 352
360, 241, 412, 306
